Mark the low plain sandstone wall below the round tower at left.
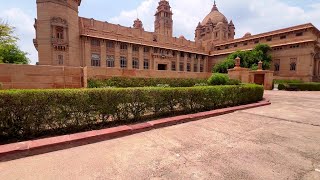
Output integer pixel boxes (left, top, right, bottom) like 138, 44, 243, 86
0, 64, 83, 89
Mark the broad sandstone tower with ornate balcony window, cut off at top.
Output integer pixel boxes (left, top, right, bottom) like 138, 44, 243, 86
34, 0, 81, 66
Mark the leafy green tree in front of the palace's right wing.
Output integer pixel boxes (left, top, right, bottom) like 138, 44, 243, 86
213, 44, 272, 73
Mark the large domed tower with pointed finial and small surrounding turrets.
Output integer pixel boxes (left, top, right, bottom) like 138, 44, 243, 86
195, 1, 235, 44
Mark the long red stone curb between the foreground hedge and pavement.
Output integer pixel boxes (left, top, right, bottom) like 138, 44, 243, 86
0, 99, 271, 162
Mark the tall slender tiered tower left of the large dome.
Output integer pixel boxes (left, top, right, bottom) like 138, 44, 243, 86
154, 0, 173, 37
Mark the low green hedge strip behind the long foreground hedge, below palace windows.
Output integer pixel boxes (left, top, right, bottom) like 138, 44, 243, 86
88, 77, 207, 88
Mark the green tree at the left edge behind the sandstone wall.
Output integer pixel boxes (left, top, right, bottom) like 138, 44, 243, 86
0, 19, 29, 64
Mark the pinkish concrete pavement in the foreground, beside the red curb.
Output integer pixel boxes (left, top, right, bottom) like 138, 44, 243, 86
0, 91, 320, 180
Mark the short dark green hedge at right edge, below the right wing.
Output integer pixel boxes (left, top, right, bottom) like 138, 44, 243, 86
278, 83, 320, 91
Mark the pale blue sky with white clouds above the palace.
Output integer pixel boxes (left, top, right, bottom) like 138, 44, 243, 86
0, 0, 320, 64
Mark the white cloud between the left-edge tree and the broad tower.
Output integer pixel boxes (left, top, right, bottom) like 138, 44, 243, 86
0, 8, 38, 64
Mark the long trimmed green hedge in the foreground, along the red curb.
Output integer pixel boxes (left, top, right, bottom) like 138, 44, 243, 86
0, 85, 263, 143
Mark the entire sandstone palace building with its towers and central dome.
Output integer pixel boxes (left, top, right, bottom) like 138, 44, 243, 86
33, 0, 320, 81
